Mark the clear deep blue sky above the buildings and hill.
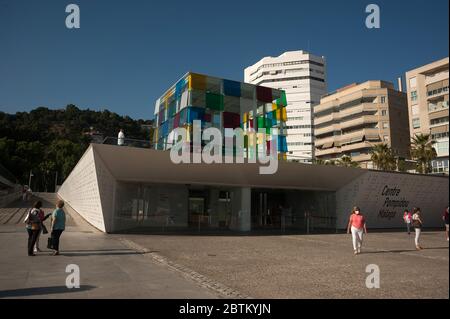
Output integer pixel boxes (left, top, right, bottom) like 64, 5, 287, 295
0, 0, 449, 119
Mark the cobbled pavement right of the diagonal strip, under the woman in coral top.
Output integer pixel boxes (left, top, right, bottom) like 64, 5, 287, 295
120, 229, 449, 299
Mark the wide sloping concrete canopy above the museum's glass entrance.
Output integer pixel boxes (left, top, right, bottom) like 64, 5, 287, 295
92, 144, 365, 191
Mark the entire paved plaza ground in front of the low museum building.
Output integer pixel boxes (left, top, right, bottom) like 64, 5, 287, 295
0, 195, 449, 299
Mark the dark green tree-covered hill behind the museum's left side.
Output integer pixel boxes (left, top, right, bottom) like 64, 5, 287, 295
0, 104, 152, 191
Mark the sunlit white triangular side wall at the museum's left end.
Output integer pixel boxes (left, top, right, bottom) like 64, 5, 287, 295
58, 146, 106, 232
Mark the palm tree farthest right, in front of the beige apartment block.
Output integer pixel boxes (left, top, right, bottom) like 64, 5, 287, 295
411, 134, 437, 174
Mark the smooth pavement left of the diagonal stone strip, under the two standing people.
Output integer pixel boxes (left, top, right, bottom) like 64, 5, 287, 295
0, 201, 220, 299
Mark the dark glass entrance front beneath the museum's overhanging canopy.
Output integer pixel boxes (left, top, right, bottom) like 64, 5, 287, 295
113, 182, 336, 232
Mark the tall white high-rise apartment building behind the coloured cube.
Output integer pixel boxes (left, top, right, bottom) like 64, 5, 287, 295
244, 51, 327, 162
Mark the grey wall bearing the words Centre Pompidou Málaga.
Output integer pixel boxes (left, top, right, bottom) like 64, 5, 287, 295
336, 171, 449, 229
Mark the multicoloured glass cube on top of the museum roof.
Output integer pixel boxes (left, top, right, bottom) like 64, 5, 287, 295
153, 73, 288, 158
